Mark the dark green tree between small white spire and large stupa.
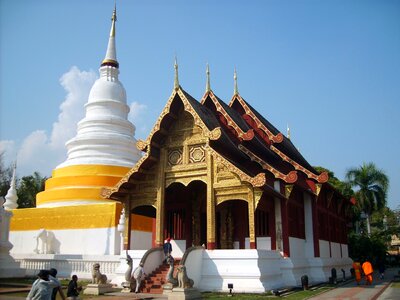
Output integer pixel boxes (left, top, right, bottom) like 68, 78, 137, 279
17, 172, 47, 208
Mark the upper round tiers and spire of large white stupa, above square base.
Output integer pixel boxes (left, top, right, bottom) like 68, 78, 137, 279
36, 9, 140, 207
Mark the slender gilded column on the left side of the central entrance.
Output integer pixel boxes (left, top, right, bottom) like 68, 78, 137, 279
155, 149, 166, 246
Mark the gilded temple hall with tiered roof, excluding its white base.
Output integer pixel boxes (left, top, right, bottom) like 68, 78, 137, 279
102, 65, 351, 257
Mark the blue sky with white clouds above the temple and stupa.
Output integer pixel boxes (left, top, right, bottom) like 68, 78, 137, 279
0, 0, 400, 208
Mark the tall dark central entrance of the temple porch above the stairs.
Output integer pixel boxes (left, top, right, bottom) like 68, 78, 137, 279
163, 181, 207, 252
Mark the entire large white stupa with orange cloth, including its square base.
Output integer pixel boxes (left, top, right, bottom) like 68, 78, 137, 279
11, 8, 140, 255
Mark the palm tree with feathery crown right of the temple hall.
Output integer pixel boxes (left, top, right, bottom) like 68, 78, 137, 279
346, 163, 389, 235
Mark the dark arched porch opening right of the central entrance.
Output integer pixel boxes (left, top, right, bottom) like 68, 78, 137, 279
216, 200, 250, 249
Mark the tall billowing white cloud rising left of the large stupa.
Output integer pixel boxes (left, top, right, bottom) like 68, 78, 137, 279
0, 66, 96, 176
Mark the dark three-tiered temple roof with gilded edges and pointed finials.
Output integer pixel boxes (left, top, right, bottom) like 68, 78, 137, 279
103, 62, 328, 199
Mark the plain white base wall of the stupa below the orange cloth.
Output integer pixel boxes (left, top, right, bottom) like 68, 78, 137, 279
10, 227, 120, 255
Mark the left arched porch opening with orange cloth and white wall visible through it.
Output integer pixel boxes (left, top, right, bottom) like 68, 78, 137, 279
129, 205, 156, 250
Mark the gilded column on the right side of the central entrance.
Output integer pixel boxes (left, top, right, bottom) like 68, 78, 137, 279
207, 152, 215, 250
